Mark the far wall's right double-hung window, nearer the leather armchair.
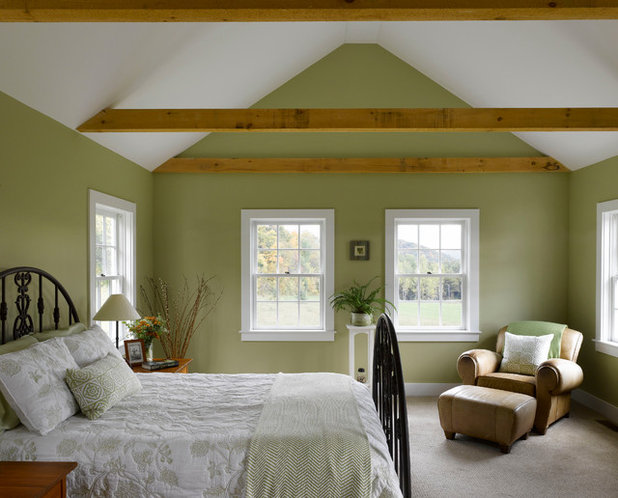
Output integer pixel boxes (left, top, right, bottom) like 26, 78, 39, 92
385, 209, 479, 342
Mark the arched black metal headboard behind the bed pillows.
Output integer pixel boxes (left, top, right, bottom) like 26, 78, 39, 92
0, 266, 79, 344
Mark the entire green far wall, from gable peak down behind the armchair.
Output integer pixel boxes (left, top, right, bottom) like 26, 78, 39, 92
155, 45, 568, 382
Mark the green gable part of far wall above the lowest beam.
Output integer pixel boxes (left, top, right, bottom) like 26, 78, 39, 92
179, 45, 539, 157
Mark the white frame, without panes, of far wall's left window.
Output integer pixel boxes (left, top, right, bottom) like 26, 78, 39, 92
240, 209, 335, 341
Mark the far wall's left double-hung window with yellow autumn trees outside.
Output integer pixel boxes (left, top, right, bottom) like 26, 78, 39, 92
241, 209, 334, 341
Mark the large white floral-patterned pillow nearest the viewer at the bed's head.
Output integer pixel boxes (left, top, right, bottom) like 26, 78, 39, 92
0, 338, 78, 436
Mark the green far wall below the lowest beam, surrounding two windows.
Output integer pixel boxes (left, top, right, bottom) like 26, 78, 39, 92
155, 174, 568, 382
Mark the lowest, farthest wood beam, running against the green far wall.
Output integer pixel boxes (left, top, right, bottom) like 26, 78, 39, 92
154, 157, 569, 173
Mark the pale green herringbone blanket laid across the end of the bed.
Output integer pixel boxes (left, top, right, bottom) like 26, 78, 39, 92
246, 373, 371, 498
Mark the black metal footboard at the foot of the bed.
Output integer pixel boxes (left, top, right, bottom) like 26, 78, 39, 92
373, 314, 412, 498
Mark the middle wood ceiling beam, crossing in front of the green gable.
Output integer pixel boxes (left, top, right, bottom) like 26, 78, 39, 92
77, 107, 618, 133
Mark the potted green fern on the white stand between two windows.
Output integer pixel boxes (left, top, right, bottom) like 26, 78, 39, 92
330, 277, 395, 326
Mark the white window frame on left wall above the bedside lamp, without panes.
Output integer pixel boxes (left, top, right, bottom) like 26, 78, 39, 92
88, 189, 137, 347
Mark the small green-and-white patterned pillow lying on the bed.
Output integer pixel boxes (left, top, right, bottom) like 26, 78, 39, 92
65, 353, 142, 420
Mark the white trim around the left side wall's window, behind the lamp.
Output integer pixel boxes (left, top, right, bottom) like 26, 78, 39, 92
88, 189, 137, 345
